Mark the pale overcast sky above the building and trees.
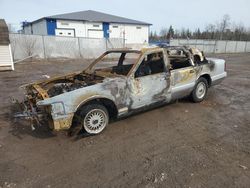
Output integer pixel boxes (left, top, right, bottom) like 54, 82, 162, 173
0, 0, 250, 31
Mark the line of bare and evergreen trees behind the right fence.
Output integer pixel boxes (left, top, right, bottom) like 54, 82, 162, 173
150, 15, 250, 41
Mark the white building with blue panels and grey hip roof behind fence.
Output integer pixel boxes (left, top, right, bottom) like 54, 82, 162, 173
23, 10, 151, 44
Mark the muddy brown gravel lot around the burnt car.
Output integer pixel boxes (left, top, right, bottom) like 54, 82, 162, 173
0, 54, 250, 188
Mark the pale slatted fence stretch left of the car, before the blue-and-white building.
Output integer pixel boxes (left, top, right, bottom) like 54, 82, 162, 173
10, 34, 125, 60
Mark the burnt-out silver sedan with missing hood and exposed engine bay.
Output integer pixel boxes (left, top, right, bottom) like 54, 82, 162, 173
14, 47, 227, 134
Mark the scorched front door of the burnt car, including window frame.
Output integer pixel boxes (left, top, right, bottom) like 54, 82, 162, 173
129, 51, 171, 109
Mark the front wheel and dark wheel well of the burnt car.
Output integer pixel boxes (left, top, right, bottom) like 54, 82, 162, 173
69, 104, 109, 136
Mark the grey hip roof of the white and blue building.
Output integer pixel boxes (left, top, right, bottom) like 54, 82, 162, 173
45, 10, 152, 25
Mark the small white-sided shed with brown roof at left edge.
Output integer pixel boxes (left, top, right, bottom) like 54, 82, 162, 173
0, 19, 14, 71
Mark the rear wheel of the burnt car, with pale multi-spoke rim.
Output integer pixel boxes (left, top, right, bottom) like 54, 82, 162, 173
191, 77, 208, 103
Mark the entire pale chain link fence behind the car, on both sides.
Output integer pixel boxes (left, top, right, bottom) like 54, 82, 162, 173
10, 34, 250, 60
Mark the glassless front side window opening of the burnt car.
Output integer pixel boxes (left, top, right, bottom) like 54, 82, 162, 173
135, 52, 166, 78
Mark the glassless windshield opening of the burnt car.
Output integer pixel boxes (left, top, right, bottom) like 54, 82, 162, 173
86, 51, 141, 76
